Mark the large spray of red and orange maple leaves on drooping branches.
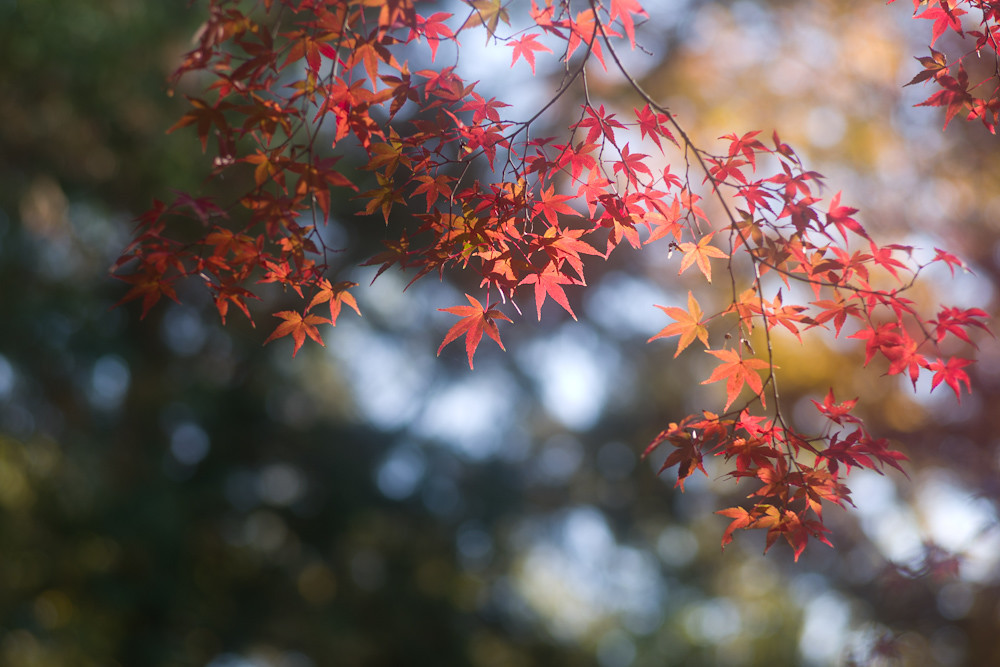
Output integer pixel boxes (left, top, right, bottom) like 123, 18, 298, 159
115, 0, 995, 558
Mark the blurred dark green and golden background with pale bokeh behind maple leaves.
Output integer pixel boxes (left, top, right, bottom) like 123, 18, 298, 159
0, 0, 1000, 667
